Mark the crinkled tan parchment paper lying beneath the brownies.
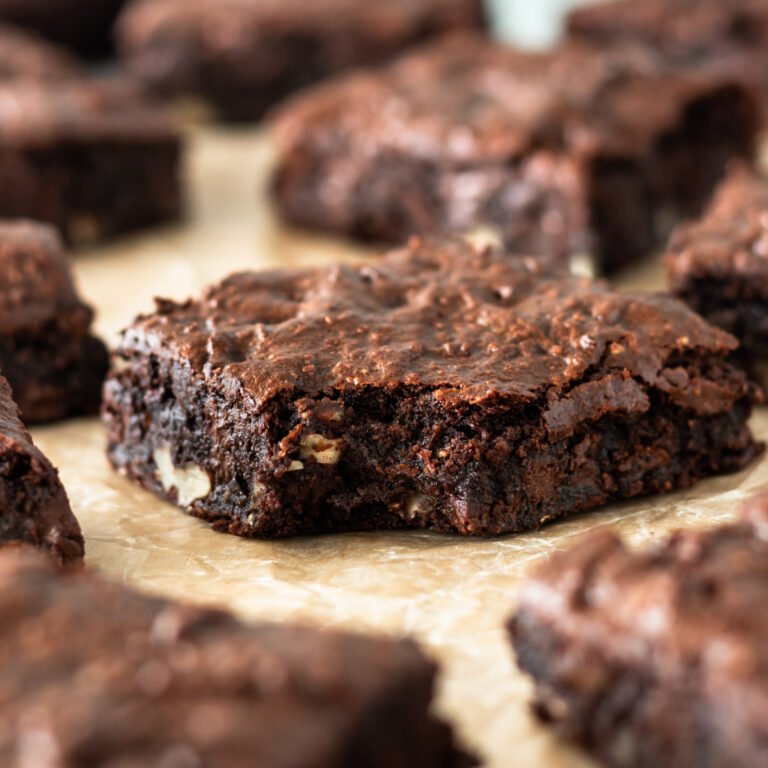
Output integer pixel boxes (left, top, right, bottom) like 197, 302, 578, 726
34, 128, 768, 768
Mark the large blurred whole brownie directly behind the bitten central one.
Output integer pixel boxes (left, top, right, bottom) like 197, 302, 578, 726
274, 37, 760, 271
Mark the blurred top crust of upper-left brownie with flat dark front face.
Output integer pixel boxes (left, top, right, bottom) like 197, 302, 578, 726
0, 79, 178, 148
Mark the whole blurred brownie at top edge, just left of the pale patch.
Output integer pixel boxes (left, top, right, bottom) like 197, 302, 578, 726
117, 0, 485, 121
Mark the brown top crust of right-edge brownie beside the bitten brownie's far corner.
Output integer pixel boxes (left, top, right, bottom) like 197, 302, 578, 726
666, 165, 768, 288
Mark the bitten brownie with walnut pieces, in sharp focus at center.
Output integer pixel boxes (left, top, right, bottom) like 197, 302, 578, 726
104, 240, 760, 538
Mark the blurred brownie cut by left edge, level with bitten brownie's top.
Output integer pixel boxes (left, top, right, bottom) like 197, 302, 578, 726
0, 222, 109, 424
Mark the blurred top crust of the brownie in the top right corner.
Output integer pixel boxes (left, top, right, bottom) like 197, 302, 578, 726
568, 0, 768, 55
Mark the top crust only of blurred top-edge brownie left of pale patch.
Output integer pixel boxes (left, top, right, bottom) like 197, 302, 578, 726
120, 0, 483, 50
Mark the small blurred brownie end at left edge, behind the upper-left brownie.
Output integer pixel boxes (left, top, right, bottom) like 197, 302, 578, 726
0, 23, 81, 81
